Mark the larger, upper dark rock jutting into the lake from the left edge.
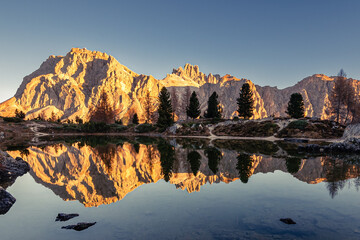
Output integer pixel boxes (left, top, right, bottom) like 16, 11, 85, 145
0, 151, 30, 187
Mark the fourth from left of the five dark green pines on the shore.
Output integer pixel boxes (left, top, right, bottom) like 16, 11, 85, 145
237, 83, 254, 119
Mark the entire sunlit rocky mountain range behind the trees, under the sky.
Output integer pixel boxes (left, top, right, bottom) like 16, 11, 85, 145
0, 48, 360, 120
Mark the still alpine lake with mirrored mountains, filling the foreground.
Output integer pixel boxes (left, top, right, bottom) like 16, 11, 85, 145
0, 136, 360, 240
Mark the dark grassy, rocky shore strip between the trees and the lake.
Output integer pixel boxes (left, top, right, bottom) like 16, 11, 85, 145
0, 118, 345, 147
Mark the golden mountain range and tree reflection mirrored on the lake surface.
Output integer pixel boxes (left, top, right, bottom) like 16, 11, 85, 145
9, 139, 360, 207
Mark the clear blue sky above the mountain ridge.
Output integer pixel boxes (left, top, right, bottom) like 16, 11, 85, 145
0, 0, 360, 101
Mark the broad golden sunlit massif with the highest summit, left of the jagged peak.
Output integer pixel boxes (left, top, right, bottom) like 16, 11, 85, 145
0, 48, 159, 120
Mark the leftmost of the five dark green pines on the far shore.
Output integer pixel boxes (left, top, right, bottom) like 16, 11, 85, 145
157, 87, 174, 127
